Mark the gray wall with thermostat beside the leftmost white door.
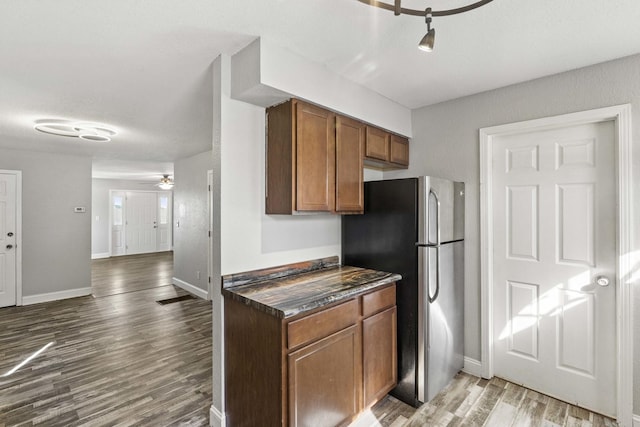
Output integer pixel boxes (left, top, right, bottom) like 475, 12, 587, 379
0, 149, 91, 296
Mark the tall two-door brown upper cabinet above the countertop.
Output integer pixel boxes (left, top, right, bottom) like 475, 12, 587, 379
266, 99, 365, 214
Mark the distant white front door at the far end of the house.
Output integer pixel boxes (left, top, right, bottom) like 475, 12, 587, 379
125, 191, 158, 255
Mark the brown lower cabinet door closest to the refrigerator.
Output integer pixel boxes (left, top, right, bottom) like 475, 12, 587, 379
362, 306, 398, 408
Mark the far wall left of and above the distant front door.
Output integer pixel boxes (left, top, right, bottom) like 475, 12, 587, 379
91, 178, 158, 255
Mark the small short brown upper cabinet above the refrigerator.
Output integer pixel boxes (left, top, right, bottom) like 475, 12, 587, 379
365, 126, 409, 169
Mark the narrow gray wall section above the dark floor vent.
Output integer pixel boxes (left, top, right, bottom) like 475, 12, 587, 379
173, 151, 213, 290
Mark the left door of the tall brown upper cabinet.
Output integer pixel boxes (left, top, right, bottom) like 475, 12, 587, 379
296, 101, 336, 212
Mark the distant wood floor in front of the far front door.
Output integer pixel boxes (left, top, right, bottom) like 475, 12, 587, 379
91, 251, 173, 297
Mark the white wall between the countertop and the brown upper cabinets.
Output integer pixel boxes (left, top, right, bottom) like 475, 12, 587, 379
220, 67, 340, 275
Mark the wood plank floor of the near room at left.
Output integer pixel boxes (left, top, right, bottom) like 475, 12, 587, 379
0, 286, 212, 427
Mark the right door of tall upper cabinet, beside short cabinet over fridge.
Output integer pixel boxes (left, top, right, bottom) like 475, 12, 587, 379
336, 116, 365, 213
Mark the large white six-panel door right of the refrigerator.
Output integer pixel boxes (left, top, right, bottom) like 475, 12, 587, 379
492, 121, 616, 416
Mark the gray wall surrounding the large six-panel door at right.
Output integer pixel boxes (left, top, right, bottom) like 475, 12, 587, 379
384, 55, 640, 414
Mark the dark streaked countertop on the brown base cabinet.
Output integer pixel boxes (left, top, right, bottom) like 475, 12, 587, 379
223, 257, 401, 318
